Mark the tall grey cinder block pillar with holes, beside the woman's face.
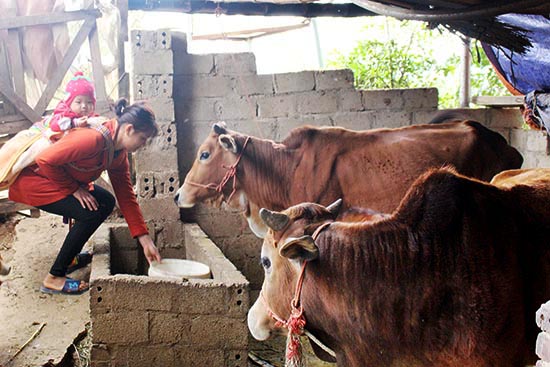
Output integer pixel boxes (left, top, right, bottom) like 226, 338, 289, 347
131, 30, 181, 257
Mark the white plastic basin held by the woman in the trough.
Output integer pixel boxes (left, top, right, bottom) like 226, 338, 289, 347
148, 259, 210, 279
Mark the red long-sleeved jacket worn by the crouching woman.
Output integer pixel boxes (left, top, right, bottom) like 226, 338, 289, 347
9, 119, 148, 237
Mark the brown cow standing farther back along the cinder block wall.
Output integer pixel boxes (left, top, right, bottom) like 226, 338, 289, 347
175, 121, 523, 237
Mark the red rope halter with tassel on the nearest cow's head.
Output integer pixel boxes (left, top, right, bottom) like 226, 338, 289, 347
260, 220, 336, 360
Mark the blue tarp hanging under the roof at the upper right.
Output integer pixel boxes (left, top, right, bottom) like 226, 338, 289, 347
483, 14, 550, 94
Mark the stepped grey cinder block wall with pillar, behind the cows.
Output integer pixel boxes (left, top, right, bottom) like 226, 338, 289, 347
128, 30, 550, 289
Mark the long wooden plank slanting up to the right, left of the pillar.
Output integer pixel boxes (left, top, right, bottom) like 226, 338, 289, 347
34, 18, 95, 115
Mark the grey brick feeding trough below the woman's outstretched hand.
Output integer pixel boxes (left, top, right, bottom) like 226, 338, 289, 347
90, 223, 249, 367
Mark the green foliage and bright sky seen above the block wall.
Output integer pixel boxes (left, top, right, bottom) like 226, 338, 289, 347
327, 18, 508, 108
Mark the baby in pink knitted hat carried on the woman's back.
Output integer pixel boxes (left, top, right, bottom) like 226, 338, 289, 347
11, 72, 105, 177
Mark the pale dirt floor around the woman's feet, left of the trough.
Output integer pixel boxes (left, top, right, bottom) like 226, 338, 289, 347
0, 212, 89, 367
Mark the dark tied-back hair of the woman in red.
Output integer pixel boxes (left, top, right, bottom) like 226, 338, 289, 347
114, 98, 158, 136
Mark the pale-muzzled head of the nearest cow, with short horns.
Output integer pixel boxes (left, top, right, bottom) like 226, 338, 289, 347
248, 199, 342, 340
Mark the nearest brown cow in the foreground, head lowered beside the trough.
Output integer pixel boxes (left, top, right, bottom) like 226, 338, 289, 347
248, 169, 550, 367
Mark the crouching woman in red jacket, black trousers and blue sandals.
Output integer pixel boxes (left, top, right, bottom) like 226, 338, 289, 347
9, 100, 161, 294
